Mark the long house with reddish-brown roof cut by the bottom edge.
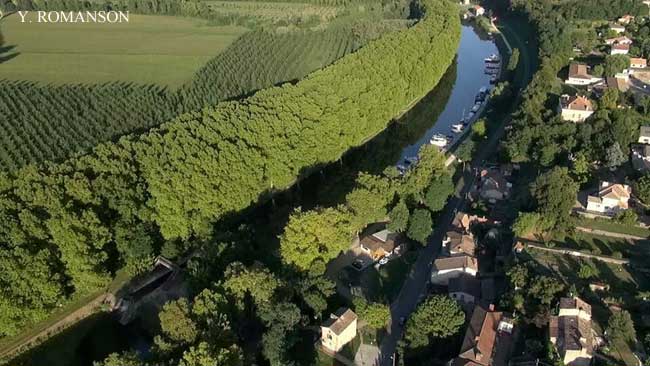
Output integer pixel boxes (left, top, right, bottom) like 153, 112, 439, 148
450, 305, 515, 366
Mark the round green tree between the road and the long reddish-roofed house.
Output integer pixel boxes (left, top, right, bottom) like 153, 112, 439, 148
404, 295, 465, 348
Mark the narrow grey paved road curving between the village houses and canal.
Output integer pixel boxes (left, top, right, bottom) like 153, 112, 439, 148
372, 17, 534, 366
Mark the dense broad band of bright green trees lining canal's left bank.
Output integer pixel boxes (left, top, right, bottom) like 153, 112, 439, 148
0, 0, 460, 356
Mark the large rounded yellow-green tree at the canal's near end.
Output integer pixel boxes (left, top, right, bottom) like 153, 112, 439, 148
280, 208, 354, 271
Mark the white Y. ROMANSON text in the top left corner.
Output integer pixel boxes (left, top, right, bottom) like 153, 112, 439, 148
18, 10, 129, 23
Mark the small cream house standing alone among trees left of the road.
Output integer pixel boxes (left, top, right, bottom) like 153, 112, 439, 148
320, 308, 357, 353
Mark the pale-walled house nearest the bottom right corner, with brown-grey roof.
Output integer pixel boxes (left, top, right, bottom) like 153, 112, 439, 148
549, 297, 594, 366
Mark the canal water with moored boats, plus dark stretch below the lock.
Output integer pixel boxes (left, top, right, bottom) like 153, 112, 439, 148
12, 25, 497, 366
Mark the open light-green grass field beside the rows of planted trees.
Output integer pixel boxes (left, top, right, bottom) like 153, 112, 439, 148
0, 12, 246, 87
